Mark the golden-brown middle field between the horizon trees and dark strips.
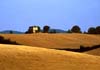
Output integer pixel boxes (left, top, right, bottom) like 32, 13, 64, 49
0, 33, 100, 48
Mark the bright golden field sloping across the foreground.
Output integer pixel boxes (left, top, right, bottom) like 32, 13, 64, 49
0, 44, 100, 70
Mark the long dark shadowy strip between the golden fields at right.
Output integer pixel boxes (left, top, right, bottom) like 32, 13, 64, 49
58, 45, 100, 52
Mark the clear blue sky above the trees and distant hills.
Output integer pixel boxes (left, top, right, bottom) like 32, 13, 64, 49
0, 0, 100, 31
